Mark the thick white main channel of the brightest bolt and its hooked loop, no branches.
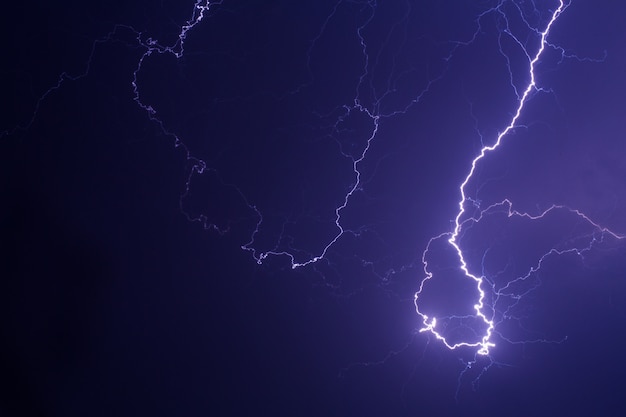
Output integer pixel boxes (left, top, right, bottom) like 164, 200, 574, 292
414, 0, 567, 355
